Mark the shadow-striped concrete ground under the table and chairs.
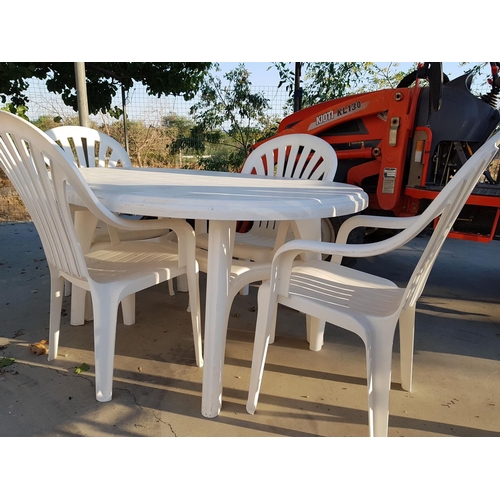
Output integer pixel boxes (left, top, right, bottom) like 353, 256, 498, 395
0, 223, 500, 437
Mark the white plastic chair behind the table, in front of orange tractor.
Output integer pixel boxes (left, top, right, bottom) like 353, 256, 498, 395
196, 134, 338, 262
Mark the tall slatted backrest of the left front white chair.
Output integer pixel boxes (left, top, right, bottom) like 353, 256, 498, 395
0, 111, 131, 280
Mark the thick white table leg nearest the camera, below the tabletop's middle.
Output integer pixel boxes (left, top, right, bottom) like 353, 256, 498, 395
201, 221, 236, 418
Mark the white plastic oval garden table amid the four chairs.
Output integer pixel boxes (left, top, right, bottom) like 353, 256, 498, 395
68, 168, 368, 417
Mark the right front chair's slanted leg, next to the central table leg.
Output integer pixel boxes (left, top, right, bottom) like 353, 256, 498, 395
246, 281, 277, 415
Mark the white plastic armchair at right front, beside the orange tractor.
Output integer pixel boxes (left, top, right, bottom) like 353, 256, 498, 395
247, 133, 500, 436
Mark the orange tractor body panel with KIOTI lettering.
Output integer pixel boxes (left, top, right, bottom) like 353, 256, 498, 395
277, 87, 421, 210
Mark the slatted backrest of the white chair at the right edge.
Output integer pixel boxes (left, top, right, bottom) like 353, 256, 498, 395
402, 132, 500, 309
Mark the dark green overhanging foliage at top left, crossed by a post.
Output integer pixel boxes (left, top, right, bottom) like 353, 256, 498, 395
0, 62, 212, 115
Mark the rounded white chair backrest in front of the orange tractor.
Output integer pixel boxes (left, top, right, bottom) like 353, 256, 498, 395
241, 134, 338, 181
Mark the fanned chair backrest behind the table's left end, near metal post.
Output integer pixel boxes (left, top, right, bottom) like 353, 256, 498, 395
46, 125, 132, 168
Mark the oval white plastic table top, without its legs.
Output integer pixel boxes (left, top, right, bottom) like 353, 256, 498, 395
76, 168, 368, 220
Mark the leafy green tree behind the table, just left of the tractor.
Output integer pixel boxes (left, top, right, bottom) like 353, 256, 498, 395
191, 64, 270, 170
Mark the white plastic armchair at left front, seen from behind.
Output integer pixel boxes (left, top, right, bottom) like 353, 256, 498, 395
0, 111, 203, 401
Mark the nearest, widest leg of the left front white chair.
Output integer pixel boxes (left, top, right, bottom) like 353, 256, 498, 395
92, 287, 119, 403
